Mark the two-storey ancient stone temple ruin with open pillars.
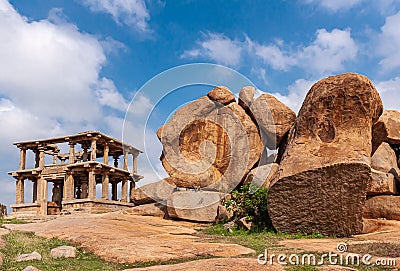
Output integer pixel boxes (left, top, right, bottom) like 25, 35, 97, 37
9, 131, 142, 217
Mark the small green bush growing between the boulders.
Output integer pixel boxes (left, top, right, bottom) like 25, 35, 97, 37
225, 183, 273, 231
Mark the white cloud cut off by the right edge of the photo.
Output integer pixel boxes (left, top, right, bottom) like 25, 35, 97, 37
378, 12, 400, 71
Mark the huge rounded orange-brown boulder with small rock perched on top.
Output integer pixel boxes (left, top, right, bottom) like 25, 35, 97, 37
157, 87, 263, 192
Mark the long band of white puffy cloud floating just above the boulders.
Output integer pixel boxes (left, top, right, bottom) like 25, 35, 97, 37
181, 28, 358, 78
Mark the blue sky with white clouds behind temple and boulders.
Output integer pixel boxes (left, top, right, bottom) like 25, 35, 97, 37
0, 0, 400, 209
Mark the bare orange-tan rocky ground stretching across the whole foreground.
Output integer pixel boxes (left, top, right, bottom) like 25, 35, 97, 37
0, 213, 400, 271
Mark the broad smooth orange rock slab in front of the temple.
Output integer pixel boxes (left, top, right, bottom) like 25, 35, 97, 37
7, 213, 254, 263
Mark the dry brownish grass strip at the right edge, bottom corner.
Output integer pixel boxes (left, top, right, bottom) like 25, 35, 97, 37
348, 242, 400, 258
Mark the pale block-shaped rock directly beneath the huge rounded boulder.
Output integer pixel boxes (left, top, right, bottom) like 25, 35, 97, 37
167, 190, 223, 222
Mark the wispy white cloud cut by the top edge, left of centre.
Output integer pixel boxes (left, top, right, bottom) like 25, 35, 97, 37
82, 0, 150, 33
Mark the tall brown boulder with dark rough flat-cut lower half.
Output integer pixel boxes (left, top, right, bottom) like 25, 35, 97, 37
268, 73, 383, 236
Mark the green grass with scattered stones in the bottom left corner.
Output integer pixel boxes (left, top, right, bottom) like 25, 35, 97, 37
0, 232, 134, 271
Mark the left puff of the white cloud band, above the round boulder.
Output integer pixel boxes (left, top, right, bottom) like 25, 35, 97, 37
181, 32, 243, 67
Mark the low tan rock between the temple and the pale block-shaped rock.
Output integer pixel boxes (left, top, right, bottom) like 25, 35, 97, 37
131, 181, 175, 205
